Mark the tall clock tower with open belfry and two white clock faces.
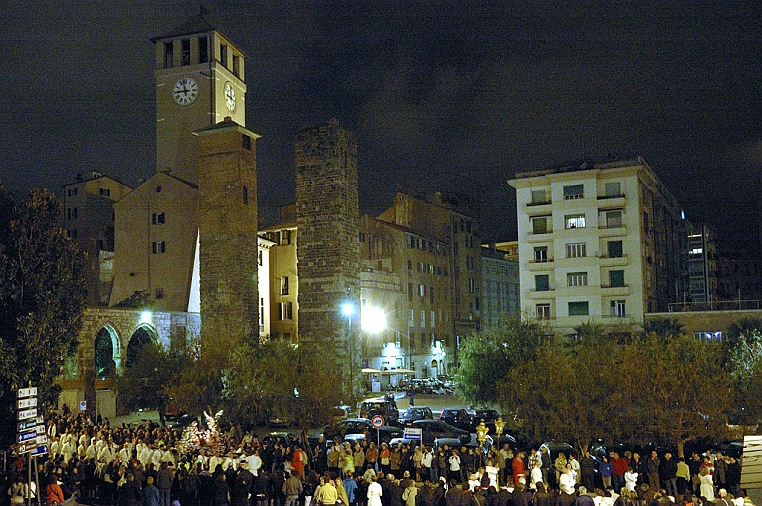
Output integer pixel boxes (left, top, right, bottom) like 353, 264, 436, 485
151, 14, 246, 184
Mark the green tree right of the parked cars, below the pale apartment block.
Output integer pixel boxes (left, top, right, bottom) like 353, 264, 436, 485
456, 314, 551, 404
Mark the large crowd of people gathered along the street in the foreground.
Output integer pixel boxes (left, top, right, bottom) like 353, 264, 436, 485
0, 412, 748, 506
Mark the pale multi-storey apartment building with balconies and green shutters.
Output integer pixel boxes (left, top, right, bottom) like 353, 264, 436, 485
508, 158, 687, 334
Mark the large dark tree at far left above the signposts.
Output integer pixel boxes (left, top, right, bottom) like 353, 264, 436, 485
0, 186, 86, 443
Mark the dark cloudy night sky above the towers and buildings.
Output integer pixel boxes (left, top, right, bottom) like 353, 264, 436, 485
0, 0, 762, 240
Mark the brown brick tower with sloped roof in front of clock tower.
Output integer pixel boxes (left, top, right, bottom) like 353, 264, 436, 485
196, 118, 259, 353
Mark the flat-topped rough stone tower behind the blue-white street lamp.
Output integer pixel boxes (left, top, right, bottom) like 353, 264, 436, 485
295, 119, 361, 394
